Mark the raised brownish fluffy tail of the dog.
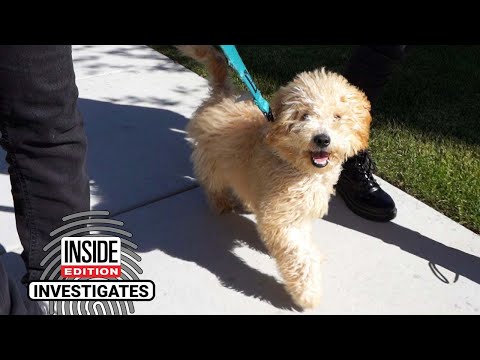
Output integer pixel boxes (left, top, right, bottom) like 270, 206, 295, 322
176, 45, 232, 94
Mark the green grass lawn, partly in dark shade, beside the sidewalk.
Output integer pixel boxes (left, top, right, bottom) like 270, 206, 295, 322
152, 45, 480, 234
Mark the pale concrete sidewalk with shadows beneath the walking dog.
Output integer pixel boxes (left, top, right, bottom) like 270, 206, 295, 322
0, 45, 480, 314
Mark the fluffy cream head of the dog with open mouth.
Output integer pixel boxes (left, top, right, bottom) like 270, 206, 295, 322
266, 69, 371, 172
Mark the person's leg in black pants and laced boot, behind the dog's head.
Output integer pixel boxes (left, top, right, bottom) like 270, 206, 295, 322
336, 45, 406, 221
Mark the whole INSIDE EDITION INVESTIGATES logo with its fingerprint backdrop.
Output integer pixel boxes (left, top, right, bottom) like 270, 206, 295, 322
28, 211, 155, 315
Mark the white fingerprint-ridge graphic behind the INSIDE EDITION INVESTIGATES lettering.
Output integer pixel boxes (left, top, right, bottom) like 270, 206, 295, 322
40, 211, 143, 315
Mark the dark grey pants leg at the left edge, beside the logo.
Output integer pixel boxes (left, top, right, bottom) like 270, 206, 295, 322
0, 45, 90, 281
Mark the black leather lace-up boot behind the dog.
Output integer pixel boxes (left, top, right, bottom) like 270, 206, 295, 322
336, 151, 397, 222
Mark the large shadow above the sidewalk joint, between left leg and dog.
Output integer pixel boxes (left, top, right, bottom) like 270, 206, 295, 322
79, 99, 195, 214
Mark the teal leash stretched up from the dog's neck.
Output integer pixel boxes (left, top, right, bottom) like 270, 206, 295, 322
220, 45, 273, 121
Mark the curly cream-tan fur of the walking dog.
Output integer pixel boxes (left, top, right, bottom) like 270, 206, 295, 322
179, 45, 371, 308
